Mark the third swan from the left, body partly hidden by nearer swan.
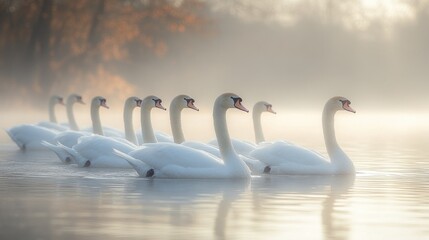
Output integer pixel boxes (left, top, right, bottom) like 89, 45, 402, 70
41, 96, 109, 163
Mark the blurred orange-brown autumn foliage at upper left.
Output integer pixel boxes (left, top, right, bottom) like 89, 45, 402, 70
0, 0, 205, 107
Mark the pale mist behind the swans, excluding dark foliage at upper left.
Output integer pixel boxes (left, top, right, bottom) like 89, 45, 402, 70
0, 0, 429, 144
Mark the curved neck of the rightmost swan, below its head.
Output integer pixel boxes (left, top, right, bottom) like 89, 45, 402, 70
322, 106, 354, 173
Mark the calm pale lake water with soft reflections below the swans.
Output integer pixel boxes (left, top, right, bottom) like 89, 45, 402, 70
0, 131, 429, 239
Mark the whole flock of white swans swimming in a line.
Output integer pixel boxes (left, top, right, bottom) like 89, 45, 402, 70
7, 93, 355, 178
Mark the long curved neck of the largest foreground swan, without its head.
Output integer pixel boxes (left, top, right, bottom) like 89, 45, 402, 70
213, 104, 238, 159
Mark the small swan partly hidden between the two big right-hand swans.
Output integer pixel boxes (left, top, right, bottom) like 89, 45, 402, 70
209, 101, 276, 156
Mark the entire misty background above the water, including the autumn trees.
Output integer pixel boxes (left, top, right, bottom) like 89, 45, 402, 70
0, 0, 429, 143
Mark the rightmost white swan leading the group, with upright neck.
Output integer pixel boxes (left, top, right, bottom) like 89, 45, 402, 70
250, 97, 356, 175
